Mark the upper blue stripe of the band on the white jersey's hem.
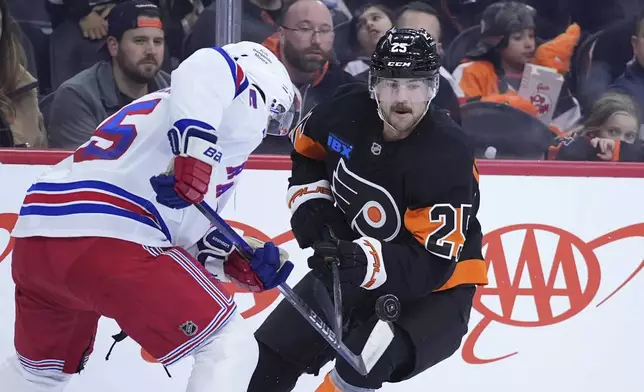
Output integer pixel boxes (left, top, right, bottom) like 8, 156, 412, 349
27, 180, 172, 242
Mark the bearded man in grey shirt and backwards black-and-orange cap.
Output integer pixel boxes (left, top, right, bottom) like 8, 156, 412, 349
49, 0, 170, 149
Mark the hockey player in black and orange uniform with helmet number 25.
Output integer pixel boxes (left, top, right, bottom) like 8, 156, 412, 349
249, 29, 487, 392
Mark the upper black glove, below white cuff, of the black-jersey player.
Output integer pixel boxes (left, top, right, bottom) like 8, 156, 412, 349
291, 199, 358, 249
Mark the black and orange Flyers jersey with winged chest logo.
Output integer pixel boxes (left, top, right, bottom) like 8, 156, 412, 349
288, 88, 487, 298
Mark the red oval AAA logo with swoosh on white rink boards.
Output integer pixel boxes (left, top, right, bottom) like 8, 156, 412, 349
462, 223, 644, 364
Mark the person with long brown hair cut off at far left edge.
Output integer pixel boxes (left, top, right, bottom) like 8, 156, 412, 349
0, 0, 47, 147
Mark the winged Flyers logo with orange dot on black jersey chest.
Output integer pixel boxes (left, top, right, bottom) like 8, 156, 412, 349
331, 158, 401, 242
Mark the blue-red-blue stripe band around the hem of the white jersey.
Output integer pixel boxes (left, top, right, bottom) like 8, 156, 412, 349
20, 180, 172, 241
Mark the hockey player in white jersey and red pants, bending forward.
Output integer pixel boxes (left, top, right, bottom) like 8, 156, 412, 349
0, 42, 293, 392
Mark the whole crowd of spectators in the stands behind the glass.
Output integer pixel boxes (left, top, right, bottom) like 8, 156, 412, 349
0, 0, 644, 162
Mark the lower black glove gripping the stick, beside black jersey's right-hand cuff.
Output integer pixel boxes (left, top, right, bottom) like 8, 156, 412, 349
308, 238, 367, 287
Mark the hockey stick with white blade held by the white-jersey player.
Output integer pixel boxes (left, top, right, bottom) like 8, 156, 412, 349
195, 201, 394, 376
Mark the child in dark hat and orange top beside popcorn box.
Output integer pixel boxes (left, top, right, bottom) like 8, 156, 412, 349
453, 1, 581, 129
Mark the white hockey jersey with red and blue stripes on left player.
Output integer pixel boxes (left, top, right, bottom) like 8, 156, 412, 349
12, 48, 269, 247
